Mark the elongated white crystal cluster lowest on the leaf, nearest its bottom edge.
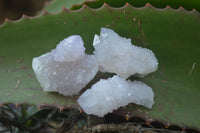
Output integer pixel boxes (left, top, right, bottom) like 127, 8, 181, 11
78, 76, 154, 117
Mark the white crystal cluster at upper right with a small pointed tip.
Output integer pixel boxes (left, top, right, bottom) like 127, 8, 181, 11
93, 28, 158, 78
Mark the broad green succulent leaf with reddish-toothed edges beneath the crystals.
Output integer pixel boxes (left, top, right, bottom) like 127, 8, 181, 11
0, 5, 200, 127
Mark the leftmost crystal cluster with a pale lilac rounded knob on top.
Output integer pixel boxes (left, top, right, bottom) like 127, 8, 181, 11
32, 35, 98, 96
